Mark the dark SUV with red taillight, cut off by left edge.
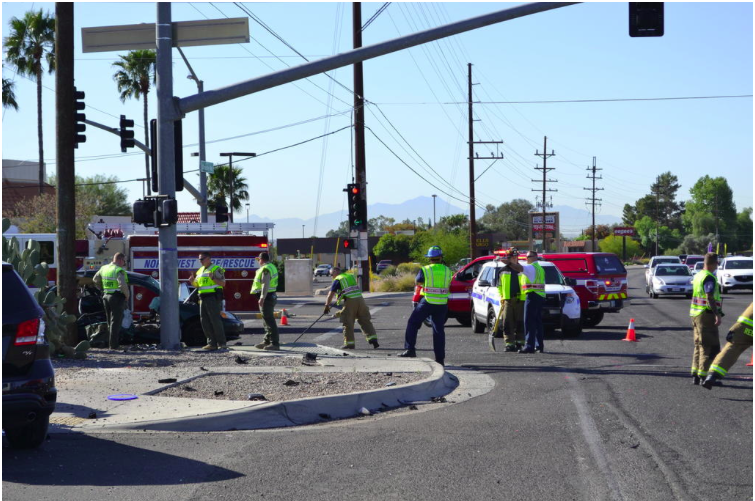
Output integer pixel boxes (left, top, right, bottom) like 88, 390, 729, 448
3, 263, 58, 448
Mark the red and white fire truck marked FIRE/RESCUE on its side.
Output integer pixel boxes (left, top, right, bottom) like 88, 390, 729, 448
85, 223, 274, 315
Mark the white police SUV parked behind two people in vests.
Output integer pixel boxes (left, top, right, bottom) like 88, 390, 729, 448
472, 261, 582, 336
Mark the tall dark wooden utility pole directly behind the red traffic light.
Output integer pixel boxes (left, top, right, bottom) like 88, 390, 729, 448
352, 2, 370, 291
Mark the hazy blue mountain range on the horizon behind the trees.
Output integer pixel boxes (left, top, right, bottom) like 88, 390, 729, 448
248, 196, 621, 238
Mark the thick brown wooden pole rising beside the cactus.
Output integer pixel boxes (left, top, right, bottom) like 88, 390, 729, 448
55, 2, 78, 346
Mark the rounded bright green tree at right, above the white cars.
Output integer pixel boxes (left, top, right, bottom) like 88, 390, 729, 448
682, 176, 737, 244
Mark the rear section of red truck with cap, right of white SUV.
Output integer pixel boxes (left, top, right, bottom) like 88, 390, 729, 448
540, 252, 629, 327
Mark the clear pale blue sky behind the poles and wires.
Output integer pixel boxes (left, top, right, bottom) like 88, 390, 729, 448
2, 2, 753, 236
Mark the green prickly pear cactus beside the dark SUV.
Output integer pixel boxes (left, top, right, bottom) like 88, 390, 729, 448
3, 218, 84, 358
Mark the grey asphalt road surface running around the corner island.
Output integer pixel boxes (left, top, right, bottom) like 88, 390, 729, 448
3, 269, 753, 501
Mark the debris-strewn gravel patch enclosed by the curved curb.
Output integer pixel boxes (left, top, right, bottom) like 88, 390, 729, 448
156, 372, 428, 402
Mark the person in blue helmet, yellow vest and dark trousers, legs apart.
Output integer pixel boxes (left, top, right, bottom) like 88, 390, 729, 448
398, 245, 453, 365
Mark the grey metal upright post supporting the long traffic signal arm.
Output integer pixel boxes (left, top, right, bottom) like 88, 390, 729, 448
155, 2, 181, 350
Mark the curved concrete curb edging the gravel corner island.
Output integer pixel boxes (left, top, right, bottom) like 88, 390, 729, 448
72, 359, 458, 433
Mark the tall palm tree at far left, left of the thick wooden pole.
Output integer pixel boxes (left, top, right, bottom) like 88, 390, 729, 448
3, 9, 55, 195
